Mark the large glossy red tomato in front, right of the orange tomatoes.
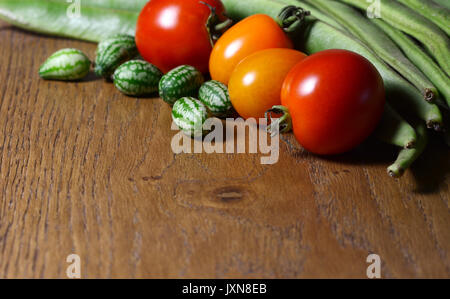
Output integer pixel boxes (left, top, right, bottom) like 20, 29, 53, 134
281, 50, 385, 155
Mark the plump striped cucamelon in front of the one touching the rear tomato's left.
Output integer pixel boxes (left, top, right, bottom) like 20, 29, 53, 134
113, 60, 163, 96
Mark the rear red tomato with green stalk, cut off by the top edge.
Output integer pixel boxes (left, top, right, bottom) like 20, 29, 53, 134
136, 0, 226, 73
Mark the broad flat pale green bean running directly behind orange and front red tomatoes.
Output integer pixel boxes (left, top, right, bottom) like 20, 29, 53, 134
222, 0, 443, 130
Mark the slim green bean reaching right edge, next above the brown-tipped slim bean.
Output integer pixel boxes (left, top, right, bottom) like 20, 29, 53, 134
372, 19, 450, 106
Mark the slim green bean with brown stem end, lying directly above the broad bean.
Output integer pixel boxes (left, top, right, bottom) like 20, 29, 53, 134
308, 0, 438, 101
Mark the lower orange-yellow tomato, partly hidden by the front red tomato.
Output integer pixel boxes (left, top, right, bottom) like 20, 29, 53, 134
228, 49, 307, 120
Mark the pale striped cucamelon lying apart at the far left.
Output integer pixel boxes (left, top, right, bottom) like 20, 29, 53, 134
39, 49, 91, 81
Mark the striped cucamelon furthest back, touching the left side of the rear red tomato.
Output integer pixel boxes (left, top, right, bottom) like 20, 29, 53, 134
95, 34, 139, 80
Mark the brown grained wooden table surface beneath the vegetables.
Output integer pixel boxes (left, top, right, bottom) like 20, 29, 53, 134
0, 23, 450, 278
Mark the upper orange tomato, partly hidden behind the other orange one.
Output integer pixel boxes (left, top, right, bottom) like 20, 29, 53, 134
209, 14, 293, 84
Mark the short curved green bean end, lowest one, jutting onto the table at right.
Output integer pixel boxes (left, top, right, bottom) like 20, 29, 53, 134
387, 124, 428, 178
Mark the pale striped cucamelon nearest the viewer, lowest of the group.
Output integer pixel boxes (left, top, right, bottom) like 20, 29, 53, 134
172, 97, 208, 137
